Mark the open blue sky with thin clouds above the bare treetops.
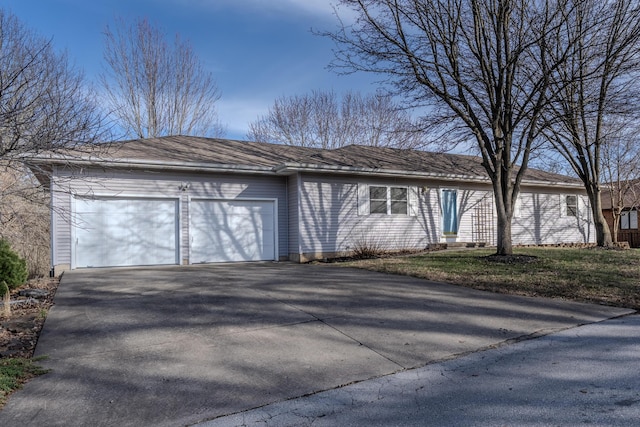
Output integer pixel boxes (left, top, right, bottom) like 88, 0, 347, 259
0, 0, 377, 139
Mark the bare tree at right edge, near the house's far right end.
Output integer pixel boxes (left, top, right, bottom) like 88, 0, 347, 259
544, 0, 640, 246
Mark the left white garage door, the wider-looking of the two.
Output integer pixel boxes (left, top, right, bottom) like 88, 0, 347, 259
74, 198, 178, 267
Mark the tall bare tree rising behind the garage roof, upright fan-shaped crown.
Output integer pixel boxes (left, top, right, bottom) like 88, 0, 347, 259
100, 19, 225, 138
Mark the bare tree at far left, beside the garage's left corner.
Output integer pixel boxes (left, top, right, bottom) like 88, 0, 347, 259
0, 9, 105, 275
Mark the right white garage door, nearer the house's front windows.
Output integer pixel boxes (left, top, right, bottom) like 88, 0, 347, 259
189, 200, 276, 263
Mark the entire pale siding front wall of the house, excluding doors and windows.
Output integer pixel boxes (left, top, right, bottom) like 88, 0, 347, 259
52, 166, 595, 268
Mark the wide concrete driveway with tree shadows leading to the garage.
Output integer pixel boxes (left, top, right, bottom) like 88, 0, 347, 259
0, 263, 631, 426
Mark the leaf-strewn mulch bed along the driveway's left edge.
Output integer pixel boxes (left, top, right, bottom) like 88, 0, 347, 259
0, 278, 59, 358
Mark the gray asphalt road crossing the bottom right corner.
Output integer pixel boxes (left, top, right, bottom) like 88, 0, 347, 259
199, 314, 640, 427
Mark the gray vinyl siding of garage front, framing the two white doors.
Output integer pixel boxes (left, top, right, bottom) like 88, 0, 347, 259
53, 170, 289, 265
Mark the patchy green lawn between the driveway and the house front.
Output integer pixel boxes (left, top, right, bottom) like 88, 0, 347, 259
344, 248, 640, 310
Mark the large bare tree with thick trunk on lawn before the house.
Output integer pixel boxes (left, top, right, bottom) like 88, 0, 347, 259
323, 0, 563, 255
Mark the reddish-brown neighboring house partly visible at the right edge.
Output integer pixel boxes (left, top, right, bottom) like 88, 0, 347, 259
602, 179, 640, 248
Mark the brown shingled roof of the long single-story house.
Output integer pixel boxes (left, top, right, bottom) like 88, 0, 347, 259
33, 136, 580, 186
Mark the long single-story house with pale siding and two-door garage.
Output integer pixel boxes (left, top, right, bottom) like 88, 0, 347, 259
26, 136, 594, 273
